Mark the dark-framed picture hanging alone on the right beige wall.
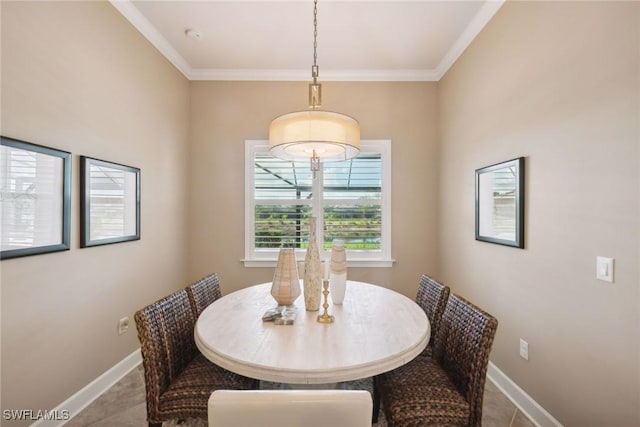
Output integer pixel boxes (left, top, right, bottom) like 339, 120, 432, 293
475, 157, 525, 249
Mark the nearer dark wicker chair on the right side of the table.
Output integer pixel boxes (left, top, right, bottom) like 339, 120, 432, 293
376, 295, 498, 427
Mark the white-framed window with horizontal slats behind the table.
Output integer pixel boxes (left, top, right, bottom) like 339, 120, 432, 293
244, 141, 391, 267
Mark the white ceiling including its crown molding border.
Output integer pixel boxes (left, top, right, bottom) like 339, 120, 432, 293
111, 0, 504, 81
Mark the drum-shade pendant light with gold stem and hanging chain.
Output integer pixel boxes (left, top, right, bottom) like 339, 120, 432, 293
269, 0, 360, 177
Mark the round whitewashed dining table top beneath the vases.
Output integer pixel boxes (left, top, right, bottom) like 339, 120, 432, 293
194, 280, 430, 384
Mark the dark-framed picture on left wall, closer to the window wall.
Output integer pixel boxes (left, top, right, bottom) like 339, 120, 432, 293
80, 156, 140, 248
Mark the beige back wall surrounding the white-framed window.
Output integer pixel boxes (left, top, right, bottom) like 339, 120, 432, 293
189, 82, 437, 296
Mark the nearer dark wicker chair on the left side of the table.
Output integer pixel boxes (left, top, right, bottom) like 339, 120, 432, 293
134, 289, 257, 427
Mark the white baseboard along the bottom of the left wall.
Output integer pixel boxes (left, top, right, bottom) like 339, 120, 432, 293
31, 349, 142, 427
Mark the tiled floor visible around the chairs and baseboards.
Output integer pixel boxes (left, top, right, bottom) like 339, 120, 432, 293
66, 366, 534, 427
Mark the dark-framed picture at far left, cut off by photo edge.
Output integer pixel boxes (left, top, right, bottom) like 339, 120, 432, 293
0, 136, 71, 260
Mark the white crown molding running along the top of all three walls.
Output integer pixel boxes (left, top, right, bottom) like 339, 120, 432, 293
109, 0, 506, 82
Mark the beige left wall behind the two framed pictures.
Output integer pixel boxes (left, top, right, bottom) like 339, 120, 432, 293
0, 1, 189, 425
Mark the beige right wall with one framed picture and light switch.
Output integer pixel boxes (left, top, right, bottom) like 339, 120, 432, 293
438, 2, 640, 426
